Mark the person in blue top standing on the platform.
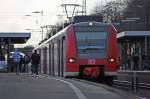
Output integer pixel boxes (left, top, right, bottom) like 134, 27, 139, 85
12, 49, 20, 75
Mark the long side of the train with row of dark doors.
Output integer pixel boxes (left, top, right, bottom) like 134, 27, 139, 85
38, 31, 66, 76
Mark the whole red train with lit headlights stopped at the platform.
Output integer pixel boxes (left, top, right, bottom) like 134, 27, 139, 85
35, 17, 119, 79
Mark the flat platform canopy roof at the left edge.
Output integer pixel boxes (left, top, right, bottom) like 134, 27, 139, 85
0, 32, 31, 44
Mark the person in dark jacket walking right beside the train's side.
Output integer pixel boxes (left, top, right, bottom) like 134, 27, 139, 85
31, 50, 40, 75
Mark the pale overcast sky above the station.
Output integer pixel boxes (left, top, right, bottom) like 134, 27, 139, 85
0, 0, 110, 46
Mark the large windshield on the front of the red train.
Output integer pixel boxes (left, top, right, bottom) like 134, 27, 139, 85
75, 31, 107, 58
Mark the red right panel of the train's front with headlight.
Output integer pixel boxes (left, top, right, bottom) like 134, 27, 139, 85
105, 25, 118, 76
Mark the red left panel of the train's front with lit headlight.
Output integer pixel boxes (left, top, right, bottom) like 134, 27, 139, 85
65, 25, 79, 76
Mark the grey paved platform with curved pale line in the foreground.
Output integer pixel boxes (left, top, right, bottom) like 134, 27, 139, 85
0, 73, 138, 99
